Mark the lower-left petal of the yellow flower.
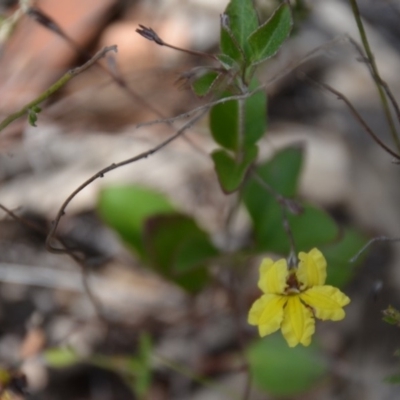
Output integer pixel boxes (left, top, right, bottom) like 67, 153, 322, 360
248, 294, 287, 336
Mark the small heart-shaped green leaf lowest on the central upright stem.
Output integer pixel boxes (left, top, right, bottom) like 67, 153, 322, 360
211, 146, 258, 193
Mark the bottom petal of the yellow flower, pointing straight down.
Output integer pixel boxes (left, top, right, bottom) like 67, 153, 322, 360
282, 295, 315, 347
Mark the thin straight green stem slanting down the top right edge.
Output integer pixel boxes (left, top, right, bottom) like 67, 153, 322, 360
350, 0, 400, 152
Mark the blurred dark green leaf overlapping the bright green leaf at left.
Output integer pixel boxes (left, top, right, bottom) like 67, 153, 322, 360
144, 214, 218, 292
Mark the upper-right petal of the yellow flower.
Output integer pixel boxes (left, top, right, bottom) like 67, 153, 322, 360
296, 248, 326, 289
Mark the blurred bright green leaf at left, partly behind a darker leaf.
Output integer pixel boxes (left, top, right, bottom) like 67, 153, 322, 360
97, 186, 174, 258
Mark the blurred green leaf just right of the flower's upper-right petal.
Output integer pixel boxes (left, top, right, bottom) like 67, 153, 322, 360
320, 229, 368, 288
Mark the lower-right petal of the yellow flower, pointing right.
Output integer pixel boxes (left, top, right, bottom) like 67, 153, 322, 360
300, 285, 350, 321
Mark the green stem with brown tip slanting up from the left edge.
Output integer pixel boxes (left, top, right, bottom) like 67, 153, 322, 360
0, 46, 117, 131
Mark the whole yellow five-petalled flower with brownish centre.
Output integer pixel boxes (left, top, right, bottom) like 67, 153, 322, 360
248, 248, 350, 347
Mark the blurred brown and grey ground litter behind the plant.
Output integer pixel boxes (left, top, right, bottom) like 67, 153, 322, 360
0, 0, 400, 400
